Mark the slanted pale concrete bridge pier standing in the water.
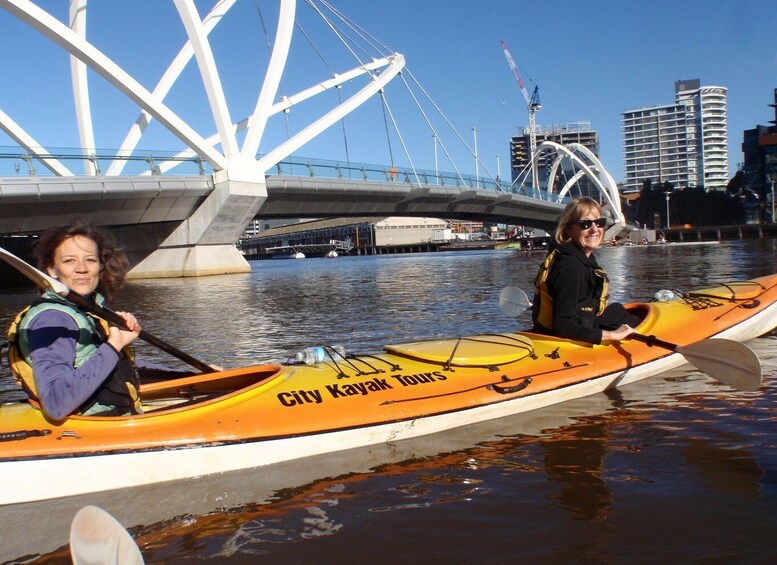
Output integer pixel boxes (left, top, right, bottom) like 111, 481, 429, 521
129, 171, 267, 279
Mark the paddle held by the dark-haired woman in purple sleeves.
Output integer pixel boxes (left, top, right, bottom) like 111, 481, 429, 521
0, 247, 216, 373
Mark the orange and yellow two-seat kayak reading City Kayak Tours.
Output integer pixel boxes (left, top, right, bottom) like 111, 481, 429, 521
0, 274, 777, 504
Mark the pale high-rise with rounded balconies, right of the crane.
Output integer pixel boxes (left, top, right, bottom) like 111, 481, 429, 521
623, 79, 728, 192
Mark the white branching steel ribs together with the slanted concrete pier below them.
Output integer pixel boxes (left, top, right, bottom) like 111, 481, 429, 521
0, 0, 405, 277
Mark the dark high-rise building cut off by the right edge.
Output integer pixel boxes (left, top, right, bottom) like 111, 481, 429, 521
742, 88, 777, 222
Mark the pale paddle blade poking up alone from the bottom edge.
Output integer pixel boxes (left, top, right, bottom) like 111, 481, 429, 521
70, 506, 144, 565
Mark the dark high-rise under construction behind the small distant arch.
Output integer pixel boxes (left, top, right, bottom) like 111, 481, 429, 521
510, 122, 599, 194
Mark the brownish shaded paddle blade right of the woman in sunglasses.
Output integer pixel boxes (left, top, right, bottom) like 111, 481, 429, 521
675, 338, 761, 392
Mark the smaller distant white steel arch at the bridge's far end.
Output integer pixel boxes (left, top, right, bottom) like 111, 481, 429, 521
532, 141, 626, 225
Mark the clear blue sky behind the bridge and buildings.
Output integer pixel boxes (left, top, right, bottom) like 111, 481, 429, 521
0, 0, 777, 180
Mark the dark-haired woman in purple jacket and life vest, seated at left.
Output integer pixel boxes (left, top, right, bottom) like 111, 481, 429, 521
9, 224, 141, 421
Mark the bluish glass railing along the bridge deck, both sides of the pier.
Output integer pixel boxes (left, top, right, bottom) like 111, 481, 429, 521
0, 147, 566, 202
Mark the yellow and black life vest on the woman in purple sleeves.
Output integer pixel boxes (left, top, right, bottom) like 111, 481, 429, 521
8, 291, 142, 415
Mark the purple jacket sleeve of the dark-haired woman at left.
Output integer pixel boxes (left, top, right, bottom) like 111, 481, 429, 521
28, 310, 119, 420
